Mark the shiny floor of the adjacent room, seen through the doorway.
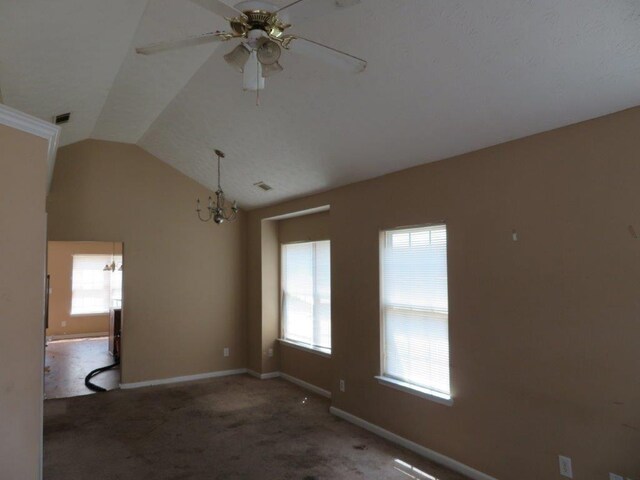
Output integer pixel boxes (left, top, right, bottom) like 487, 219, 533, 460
44, 337, 120, 398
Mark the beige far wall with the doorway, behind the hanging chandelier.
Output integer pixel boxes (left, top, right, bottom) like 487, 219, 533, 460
48, 140, 247, 383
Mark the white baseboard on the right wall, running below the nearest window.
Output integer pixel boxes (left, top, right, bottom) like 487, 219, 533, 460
329, 407, 497, 480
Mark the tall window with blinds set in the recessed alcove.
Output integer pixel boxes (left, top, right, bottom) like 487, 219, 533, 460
281, 240, 331, 352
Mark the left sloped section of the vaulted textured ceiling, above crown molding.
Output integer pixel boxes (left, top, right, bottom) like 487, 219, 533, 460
0, 0, 146, 145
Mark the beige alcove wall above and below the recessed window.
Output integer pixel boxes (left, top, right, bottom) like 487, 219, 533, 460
277, 212, 332, 391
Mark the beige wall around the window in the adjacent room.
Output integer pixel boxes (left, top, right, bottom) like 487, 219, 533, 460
47, 242, 122, 336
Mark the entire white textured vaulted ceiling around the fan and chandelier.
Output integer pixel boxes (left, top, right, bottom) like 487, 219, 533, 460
0, 0, 640, 208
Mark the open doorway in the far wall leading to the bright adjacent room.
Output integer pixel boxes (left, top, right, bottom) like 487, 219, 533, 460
44, 241, 124, 399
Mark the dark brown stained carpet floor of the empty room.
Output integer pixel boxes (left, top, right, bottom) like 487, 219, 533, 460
44, 375, 465, 480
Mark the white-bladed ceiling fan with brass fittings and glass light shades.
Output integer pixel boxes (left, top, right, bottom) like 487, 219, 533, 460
136, 0, 367, 92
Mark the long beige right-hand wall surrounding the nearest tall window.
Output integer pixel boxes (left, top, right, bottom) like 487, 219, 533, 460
248, 108, 640, 480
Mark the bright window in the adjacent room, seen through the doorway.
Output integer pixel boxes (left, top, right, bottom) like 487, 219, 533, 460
71, 255, 122, 315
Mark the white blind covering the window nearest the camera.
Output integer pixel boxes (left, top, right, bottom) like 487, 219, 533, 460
382, 225, 451, 396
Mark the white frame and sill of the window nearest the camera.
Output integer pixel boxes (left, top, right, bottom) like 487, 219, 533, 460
375, 222, 453, 406
